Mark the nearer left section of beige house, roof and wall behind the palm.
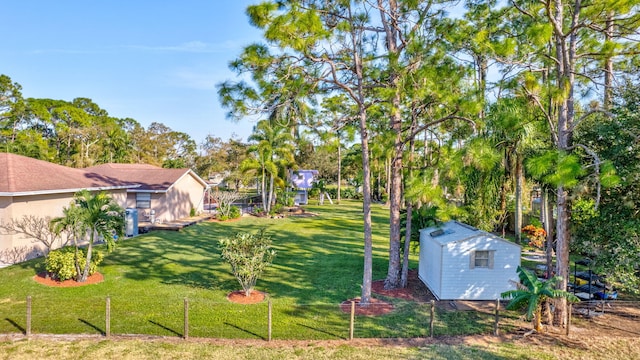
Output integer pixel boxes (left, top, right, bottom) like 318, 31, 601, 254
0, 153, 136, 265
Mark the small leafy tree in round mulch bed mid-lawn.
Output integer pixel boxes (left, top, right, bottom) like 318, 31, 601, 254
219, 229, 276, 296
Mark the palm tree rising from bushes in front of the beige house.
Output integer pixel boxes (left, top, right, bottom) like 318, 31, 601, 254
52, 189, 124, 282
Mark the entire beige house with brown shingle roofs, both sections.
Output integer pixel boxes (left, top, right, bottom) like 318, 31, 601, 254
0, 153, 208, 265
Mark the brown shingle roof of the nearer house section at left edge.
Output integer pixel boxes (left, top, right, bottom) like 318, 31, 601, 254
0, 153, 131, 194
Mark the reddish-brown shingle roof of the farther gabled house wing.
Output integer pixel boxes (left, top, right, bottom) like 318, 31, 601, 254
84, 164, 191, 191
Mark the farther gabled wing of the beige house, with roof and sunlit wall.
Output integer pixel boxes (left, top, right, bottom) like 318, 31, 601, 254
84, 164, 209, 223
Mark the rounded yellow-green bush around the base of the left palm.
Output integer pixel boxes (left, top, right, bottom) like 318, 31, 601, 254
45, 246, 104, 281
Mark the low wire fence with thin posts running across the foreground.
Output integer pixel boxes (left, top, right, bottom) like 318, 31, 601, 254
0, 296, 640, 341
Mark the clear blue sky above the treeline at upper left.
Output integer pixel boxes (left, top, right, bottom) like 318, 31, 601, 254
0, 0, 261, 144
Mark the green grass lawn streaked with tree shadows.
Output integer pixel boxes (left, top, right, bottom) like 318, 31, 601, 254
0, 201, 492, 340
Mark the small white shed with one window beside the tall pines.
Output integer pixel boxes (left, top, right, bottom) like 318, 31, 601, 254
418, 220, 521, 300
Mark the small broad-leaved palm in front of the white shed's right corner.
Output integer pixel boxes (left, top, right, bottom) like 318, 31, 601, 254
500, 266, 578, 332
